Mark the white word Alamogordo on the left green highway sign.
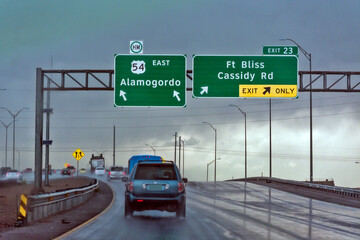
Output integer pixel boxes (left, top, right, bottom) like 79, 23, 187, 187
120, 78, 181, 88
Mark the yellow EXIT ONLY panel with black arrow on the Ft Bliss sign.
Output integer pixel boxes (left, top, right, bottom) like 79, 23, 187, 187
239, 85, 297, 98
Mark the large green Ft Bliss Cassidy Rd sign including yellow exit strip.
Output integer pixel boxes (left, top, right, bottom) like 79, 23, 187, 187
193, 55, 298, 98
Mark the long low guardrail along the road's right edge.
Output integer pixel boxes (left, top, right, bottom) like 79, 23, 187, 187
239, 177, 360, 198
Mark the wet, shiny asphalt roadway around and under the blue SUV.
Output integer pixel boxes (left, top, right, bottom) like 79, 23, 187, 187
59, 174, 360, 240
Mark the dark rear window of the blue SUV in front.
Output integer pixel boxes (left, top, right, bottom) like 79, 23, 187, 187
134, 164, 177, 180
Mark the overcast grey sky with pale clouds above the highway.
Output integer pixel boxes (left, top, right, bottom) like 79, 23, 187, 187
0, 0, 360, 187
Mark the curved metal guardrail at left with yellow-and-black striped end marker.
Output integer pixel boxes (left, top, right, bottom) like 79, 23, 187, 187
17, 179, 99, 226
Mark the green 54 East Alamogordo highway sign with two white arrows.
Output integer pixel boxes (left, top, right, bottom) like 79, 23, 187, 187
114, 54, 186, 107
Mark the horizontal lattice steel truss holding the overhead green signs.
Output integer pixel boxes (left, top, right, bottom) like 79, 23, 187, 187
41, 70, 360, 92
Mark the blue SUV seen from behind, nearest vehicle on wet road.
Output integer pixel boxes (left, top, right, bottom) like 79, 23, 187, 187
122, 161, 187, 217
